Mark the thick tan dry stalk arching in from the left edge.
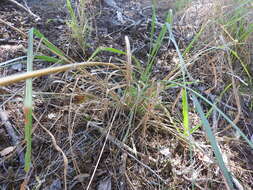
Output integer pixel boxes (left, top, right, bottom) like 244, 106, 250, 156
0, 62, 119, 86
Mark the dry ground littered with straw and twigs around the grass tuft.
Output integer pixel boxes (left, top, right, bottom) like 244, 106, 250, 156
0, 0, 253, 190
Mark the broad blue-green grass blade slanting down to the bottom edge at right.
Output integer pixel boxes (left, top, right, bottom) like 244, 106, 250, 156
192, 95, 234, 189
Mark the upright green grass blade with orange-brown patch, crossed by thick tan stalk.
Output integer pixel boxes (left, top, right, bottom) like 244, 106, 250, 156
24, 28, 34, 172
